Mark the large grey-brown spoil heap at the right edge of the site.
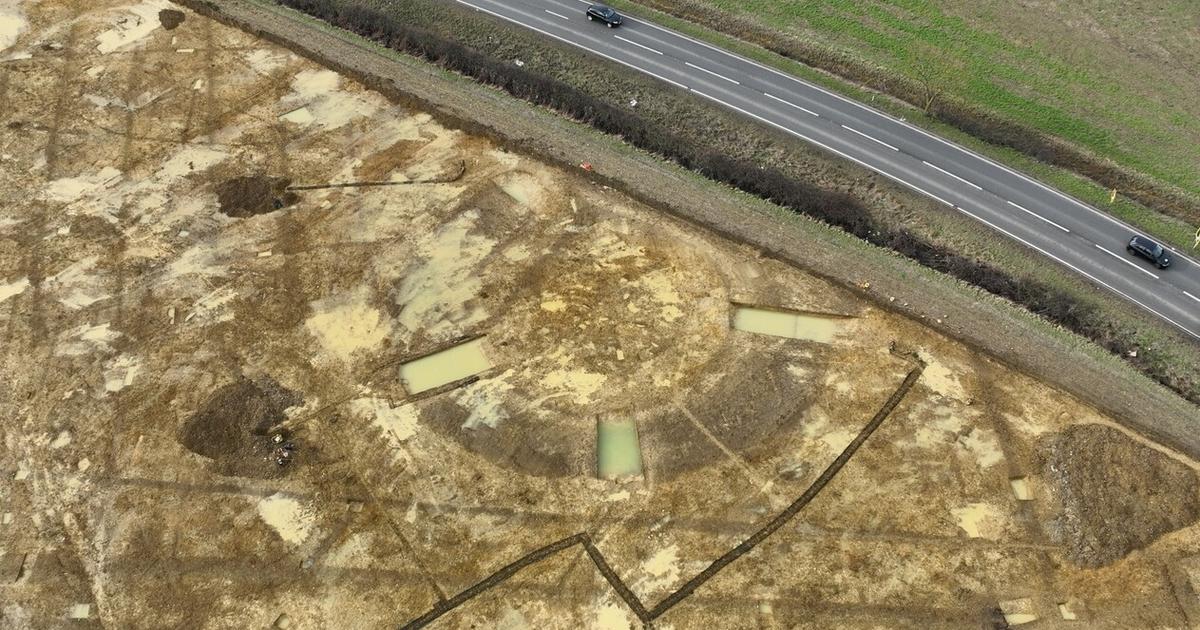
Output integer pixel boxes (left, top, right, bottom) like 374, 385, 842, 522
1044, 425, 1200, 566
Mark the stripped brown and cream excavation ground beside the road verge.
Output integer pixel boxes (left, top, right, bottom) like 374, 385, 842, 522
0, 0, 1200, 629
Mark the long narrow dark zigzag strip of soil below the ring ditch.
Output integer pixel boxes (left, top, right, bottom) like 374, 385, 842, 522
402, 360, 925, 630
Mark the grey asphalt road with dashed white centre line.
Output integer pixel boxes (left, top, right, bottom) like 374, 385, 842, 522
455, 0, 1200, 340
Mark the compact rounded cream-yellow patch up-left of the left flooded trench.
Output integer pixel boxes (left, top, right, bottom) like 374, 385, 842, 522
305, 290, 391, 361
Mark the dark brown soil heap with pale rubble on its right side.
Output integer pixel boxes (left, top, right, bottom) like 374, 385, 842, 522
180, 378, 301, 478
